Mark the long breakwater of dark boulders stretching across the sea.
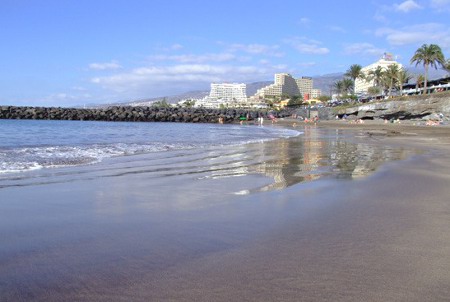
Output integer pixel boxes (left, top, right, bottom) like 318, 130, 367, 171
0, 106, 287, 123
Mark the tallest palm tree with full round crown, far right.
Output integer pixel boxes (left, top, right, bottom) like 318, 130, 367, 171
410, 44, 445, 93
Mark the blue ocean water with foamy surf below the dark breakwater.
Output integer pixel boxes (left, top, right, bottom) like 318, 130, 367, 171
0, 120, 300, 177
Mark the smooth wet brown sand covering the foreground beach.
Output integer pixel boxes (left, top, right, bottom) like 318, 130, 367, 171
0, 120, 450, 301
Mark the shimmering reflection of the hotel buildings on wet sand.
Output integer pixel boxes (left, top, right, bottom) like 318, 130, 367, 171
211, 126, 412, 191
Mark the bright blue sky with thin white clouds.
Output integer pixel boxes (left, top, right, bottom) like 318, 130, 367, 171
0, 0, 450, 107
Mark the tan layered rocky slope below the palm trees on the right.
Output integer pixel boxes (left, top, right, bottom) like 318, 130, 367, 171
336, 92, 450, 120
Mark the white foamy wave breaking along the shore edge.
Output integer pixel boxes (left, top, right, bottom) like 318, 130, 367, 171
0, 128, 300, 174
